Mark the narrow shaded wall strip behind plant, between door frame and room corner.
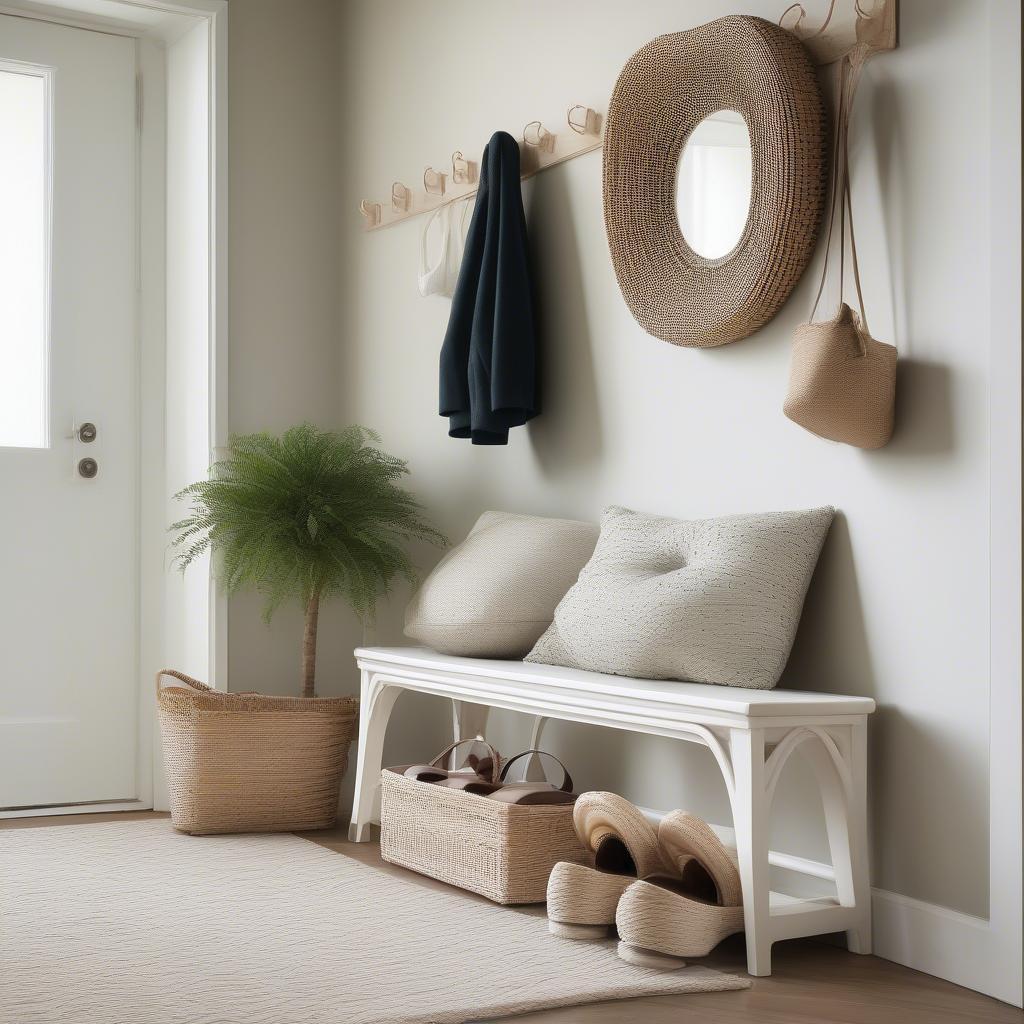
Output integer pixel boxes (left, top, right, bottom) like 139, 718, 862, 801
228, 0, 351, 693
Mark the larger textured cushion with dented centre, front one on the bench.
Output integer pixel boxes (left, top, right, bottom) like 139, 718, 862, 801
526, 507, 834, 689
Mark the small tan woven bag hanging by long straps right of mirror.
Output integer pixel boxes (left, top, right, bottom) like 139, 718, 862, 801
782, 57, 896, 449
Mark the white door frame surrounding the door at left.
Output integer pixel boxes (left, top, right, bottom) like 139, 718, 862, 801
0, 0, 228, 817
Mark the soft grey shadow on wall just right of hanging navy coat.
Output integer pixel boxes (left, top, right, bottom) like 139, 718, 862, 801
525, 170, 602, 477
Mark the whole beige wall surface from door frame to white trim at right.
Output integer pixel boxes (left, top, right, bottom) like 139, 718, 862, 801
230, 0, 991, 915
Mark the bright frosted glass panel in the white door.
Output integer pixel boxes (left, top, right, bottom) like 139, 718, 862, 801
0, 70, 49, 447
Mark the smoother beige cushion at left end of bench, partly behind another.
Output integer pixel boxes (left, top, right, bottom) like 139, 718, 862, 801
406, 512, 598, 658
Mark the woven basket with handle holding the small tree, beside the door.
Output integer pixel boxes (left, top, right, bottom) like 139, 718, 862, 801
157, 669, 359, 836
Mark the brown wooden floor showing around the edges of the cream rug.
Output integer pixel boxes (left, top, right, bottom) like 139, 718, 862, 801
0, 812, 1024, 1024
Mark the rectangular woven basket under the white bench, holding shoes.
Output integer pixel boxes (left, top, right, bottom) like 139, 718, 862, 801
381, 768, 591, 903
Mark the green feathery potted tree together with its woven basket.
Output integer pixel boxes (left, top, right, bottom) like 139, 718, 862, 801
158, 424, 444, 833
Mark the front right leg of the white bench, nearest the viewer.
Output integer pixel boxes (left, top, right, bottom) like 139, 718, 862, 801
729, 729, 772, 978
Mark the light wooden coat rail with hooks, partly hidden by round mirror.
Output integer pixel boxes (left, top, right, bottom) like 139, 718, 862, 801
359, 0, 899, 231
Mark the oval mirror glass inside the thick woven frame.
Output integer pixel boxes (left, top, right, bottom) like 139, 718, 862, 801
676, 111, 752, 259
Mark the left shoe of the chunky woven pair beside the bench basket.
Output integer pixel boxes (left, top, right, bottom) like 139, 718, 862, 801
548, 793, 675, 939
